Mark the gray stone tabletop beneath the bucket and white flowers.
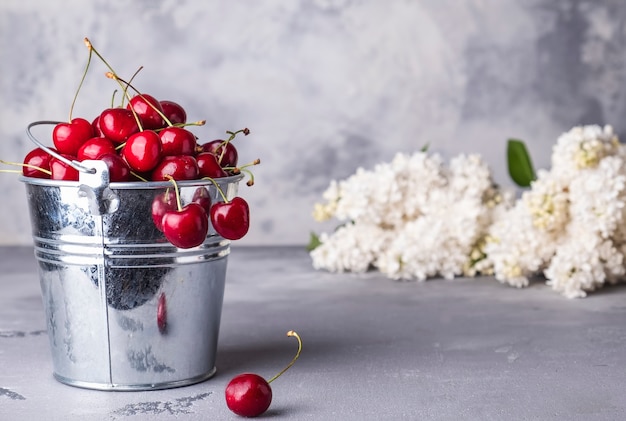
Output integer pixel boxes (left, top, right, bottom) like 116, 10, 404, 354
0, 246, 626, 421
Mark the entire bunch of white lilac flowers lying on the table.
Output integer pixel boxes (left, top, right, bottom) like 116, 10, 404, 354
311, 125, 626, 298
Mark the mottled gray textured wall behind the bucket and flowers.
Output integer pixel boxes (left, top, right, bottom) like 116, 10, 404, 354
0, 0, 626, 244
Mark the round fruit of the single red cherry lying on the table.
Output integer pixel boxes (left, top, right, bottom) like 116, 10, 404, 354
226, 373, 272, 417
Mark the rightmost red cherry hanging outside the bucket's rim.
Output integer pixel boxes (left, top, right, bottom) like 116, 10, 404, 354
210, 197, 250, 240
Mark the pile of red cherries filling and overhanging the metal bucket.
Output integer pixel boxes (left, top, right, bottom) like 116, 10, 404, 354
12, 38, 260, 248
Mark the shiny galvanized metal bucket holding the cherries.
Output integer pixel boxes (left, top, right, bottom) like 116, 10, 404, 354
21, 121, 242, 390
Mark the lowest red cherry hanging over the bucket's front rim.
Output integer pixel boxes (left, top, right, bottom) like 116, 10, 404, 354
163, 203, 209, 248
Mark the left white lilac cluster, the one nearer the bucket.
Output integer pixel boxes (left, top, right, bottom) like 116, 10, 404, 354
311, 152, 510, 280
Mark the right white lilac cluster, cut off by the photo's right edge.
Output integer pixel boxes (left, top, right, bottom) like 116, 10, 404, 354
485, 126, 626, 298
